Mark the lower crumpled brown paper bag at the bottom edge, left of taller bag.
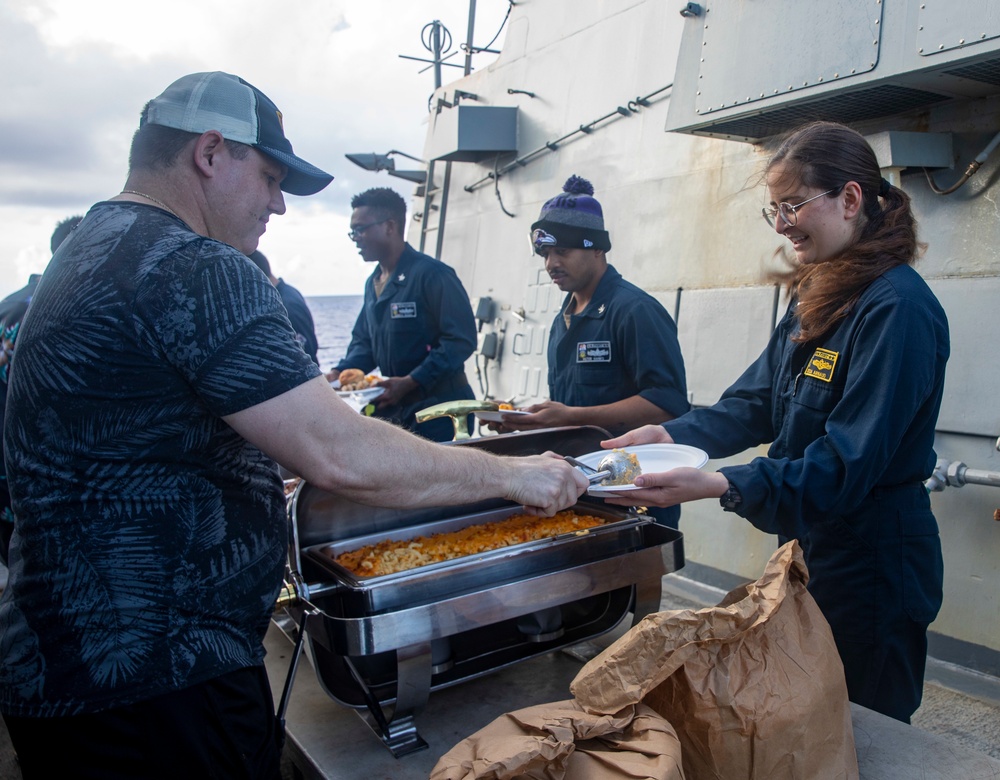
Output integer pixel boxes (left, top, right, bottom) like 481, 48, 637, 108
430, 701, 684, 780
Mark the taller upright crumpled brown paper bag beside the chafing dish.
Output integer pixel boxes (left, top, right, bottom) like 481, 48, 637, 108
570, 541, 858, 780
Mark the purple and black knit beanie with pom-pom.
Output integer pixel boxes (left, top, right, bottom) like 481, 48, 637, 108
531, 176, 611, 254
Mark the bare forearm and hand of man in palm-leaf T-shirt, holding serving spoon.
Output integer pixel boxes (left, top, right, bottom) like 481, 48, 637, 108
224, 377, 587, 515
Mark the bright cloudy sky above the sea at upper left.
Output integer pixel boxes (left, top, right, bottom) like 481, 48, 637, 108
0, 0, 508, 296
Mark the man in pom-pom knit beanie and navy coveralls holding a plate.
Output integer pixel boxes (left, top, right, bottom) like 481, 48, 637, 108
490, 176, 689, 528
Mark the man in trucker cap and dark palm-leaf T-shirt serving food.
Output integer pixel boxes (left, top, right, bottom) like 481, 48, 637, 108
0, 73, 586, 780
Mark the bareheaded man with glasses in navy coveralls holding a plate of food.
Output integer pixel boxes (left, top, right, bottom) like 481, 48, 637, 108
327, 188, 476, 441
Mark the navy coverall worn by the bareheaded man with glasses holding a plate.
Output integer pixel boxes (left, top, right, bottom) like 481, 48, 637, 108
336, 244, 476, 441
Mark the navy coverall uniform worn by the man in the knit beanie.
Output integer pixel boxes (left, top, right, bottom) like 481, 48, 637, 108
548, 265, 690, 528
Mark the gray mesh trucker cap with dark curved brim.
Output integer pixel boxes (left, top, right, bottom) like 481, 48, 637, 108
142, 71, 333, 195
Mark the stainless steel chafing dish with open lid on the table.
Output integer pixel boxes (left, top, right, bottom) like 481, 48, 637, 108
275, 427, 683, 757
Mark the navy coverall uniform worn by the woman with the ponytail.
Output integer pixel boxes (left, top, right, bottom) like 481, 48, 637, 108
664, 266, 950, 722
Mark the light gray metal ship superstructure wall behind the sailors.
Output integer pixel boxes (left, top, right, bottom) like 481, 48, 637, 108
400, 0, 1000, 674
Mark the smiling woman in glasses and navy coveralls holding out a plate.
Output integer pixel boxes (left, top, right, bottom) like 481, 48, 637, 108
605, 123, 950, 722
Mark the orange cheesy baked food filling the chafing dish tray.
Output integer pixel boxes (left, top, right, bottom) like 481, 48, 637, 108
334, 510, 606, 577
